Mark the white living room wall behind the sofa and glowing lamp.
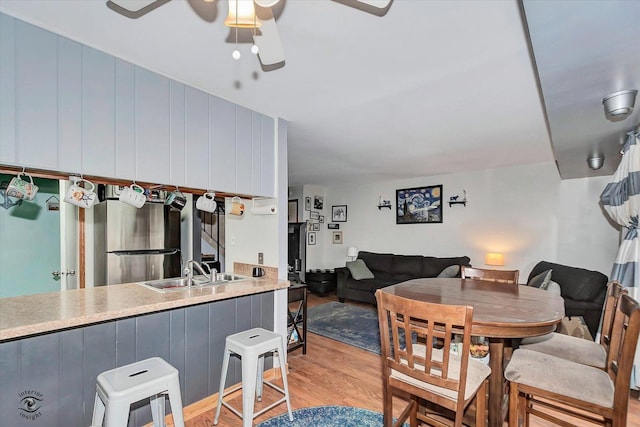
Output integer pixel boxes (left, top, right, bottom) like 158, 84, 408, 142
316, 162, 618, 281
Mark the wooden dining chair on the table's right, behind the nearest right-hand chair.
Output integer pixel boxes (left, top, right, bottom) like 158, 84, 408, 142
519, 281, 627, 369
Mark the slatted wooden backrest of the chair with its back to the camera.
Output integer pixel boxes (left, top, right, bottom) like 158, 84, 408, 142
376, 290, 473, 404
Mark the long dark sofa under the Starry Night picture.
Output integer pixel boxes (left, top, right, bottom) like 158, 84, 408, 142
335, 251, 470, 304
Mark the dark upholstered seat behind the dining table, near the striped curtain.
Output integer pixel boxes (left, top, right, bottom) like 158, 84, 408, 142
528, 261, 609, 337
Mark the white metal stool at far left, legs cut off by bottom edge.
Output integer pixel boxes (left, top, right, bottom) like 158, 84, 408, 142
91, 357, 184, 427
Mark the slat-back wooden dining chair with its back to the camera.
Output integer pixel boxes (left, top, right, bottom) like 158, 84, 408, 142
376, 290, 491, 427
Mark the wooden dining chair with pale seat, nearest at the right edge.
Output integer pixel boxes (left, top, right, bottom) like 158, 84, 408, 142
505, 295, 640, 427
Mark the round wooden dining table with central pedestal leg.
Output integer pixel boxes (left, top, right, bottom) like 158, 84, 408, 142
382, 278, 564, 427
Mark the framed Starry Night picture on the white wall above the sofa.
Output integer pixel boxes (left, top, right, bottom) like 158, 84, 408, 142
396, 185, 443, 224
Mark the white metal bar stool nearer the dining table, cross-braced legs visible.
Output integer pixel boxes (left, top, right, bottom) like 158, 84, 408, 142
213, 328, 293, 427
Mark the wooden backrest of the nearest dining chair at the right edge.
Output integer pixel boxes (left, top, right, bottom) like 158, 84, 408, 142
607, 295, 640, 420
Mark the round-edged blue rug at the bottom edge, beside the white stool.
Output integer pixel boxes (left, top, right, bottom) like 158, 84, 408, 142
256, 406, 408, 427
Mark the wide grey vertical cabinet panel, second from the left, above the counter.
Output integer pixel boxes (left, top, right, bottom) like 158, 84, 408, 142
15, 21, 58, 169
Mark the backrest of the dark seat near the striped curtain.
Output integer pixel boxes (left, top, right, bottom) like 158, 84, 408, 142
529, 261, 608, 301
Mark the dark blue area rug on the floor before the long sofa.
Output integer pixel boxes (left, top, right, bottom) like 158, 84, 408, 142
307, 301, 380, 354
